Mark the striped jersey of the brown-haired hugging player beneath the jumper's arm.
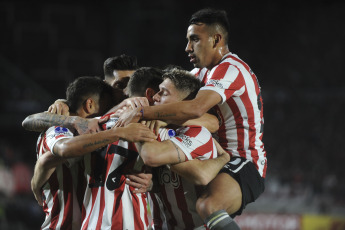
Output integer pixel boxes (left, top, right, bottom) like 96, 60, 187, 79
150, 126, 217, 230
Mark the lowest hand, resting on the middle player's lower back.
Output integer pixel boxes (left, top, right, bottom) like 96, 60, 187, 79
126, 173, 153, 193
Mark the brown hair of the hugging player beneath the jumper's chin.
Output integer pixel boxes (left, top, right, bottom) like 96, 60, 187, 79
163, 69, 201, 100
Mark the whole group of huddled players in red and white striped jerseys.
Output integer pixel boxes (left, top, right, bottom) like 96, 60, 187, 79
23, 8, 267, 230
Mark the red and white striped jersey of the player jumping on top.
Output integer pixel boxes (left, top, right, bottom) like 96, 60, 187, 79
191, 53, 267, 177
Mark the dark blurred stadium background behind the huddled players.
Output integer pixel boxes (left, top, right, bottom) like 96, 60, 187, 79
0, 0, 345, 229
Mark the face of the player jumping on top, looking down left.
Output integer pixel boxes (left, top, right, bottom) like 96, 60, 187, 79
185, 24, 215, 68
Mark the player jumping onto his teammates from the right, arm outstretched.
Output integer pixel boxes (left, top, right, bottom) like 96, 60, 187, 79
119, 9, 267, 229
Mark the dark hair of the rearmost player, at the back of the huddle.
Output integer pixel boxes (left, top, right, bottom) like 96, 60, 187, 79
103, 54, 139, 76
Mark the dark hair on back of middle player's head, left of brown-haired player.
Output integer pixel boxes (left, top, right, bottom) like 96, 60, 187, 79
127, 67, 164, 97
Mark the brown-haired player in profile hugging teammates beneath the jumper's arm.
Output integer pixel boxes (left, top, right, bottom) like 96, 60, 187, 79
138, 70, 230, 229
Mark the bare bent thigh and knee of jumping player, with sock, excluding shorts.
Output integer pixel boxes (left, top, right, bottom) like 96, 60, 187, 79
196, 173, 242, 230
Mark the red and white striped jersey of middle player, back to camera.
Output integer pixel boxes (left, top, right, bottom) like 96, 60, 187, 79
81, 119, 148, 230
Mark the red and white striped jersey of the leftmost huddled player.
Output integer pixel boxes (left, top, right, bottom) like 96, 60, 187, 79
36, 126, 84, 230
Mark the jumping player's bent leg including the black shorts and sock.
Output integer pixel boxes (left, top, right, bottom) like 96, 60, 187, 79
196, 157, 265, 230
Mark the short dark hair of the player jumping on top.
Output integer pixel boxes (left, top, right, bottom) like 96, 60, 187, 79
189, 8, 230, 42
